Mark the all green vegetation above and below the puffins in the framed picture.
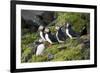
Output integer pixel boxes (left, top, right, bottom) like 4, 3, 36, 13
21, 12, 90, 63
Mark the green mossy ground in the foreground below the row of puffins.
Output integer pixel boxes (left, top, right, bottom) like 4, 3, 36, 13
22, 34, 90, 62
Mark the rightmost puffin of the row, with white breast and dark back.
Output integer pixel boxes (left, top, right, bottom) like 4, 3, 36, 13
65, 23, 79, 39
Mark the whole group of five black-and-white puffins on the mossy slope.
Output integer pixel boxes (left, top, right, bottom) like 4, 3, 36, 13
34, 23, 86, 56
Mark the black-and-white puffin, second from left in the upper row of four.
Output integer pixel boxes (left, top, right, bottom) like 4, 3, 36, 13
44, 28, 58, 44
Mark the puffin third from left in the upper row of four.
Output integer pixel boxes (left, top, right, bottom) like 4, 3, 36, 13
56, 26, 67, 43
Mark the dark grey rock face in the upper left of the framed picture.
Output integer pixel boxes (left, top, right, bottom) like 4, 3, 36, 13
21, 10, 54, 32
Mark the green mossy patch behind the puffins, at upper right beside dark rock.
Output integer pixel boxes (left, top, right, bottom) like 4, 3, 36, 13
56, 12, 90, 32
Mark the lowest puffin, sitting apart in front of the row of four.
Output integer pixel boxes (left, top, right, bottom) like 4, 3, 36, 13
34, 39, 45, 56
